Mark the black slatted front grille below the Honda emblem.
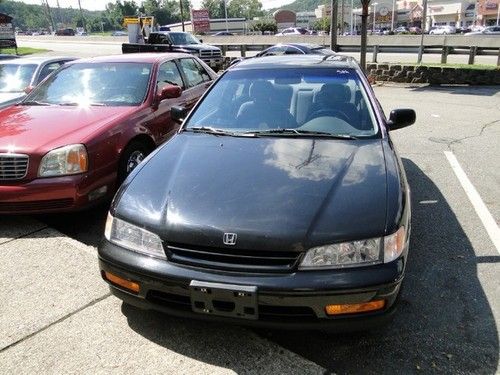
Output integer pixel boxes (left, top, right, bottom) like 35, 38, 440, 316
167, 243, 300, 272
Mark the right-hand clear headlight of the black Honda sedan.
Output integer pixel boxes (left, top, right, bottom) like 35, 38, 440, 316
299, 227, 406, 270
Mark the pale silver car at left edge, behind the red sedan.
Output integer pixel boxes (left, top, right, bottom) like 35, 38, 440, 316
0, 56, 75, 108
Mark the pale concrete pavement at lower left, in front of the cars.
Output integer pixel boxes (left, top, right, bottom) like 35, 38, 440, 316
0, 216, 324, 374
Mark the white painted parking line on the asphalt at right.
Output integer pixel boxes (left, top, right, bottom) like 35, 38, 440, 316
444, 151, 500, 253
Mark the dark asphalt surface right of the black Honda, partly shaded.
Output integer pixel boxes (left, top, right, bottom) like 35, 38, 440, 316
34, 85, 500, 374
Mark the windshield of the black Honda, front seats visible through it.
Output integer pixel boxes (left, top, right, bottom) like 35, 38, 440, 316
185, 67, 378, 138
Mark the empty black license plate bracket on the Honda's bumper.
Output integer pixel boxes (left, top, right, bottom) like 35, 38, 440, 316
189, 280, 259, 320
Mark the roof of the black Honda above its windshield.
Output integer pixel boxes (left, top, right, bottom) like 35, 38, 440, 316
231, 55, 359, 70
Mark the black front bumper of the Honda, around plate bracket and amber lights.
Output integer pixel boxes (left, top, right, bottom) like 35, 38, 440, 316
99, 241, 405, 331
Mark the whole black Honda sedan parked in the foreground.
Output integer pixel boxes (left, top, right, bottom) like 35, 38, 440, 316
99, 55, 415, 330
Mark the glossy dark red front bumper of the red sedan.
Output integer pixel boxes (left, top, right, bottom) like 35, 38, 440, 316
0, 174, 115, 214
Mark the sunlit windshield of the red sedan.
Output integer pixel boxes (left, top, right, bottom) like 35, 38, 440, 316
21, 63, 152, 106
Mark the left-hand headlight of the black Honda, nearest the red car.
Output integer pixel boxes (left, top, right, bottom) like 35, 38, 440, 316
104, 213, 167, 259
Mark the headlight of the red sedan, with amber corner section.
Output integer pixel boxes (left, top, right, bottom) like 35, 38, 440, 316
38, 144, 88, 177
